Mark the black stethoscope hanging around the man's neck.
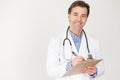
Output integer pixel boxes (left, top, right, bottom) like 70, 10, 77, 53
63, 27, 93, 59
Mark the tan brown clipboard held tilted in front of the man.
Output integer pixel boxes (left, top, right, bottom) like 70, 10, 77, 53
63, 59, 102, 77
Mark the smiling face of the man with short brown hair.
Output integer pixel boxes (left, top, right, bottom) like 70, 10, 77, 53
68, 6, 87, 31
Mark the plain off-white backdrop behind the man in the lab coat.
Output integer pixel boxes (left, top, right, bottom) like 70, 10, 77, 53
0, 0, 120, 80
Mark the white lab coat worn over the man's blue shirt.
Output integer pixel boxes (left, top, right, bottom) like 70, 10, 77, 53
47, 30, 104, 80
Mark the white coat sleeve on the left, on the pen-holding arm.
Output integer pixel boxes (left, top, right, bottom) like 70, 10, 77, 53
47, 39, 67, 78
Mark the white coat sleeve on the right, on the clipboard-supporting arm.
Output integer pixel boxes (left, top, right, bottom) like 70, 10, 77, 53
95, 41, 104, 77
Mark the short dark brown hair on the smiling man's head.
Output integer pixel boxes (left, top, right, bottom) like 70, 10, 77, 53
68, 0, 90, 16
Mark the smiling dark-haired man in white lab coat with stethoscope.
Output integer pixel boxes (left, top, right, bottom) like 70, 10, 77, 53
47, 0, 104, 80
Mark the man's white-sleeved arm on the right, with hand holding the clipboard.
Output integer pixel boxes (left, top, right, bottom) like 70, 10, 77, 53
85, 40, 104, 78
